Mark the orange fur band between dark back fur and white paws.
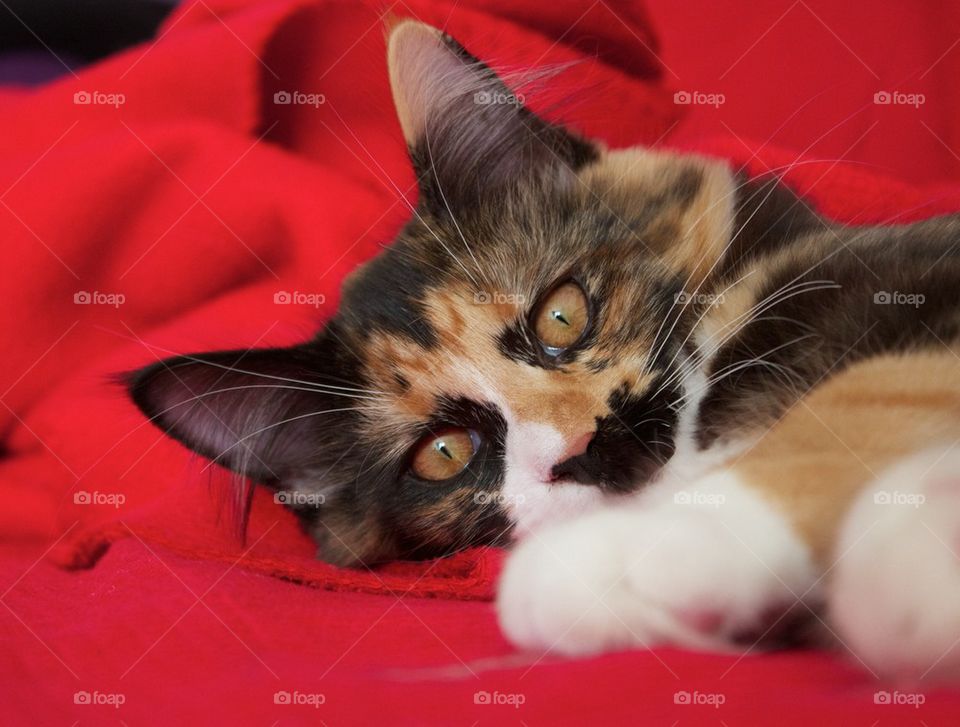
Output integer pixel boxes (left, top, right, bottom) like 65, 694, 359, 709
732, 350, 960, 566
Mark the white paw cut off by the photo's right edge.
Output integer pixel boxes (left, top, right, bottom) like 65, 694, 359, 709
829, 447, 960, 680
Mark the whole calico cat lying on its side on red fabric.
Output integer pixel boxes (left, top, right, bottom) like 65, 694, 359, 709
129, 21, 960, 676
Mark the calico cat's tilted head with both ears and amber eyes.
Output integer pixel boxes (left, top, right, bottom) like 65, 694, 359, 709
130, 21, 733, 564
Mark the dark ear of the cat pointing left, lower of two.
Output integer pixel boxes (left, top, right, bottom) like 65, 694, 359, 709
127, 348, 350, 482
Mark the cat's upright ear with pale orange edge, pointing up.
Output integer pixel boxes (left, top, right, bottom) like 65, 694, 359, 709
387, 20, 599, 205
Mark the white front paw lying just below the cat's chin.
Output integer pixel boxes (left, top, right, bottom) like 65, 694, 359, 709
497, 472, 819, 654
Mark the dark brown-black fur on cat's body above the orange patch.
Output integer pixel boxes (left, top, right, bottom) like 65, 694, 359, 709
697, 216, 960, 448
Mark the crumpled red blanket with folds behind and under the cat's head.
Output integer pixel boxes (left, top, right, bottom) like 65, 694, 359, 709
0, 0, 677, 598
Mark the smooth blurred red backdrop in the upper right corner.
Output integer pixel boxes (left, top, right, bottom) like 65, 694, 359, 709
647, 0, 960, 185
